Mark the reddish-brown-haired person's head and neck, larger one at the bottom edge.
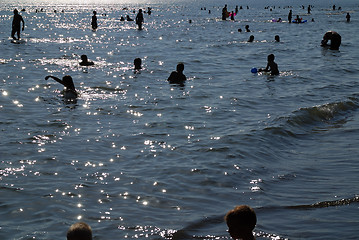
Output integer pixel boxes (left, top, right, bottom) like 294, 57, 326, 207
224, 205, 257, 240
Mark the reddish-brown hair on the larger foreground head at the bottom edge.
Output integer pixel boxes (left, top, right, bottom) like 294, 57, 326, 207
224, 205, 257, 231
